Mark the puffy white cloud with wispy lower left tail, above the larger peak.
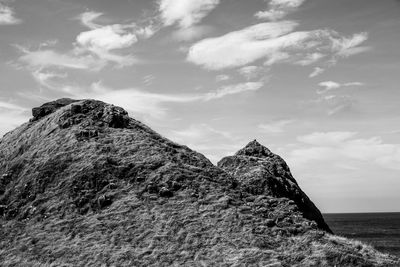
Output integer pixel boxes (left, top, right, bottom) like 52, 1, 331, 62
17, 11, 144, 71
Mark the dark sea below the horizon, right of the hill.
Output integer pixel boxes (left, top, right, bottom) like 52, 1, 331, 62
324, 212, 400, 257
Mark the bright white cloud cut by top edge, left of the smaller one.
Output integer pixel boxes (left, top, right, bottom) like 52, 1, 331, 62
159, 0, 219, 28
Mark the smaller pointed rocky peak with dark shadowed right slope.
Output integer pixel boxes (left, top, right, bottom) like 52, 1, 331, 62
218, 140, 331, 233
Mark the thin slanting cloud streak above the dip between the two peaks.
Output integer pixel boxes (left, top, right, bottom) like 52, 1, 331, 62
201, 82, 264, 101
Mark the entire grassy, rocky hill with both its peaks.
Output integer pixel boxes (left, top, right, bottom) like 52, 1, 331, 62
0, 99, 400, 266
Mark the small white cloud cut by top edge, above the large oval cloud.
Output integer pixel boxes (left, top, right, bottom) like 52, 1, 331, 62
255, 0, 305, 21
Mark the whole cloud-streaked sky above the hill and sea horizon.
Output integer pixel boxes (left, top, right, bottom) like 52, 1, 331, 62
0, 0, 400, 212
